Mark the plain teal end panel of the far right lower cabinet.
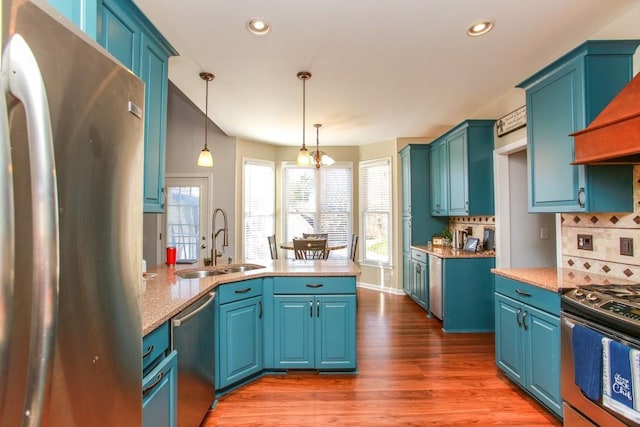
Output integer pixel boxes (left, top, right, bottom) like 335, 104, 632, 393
442, 257, 495, 332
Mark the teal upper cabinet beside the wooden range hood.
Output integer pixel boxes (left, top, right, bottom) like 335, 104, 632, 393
518, 40, 640, 212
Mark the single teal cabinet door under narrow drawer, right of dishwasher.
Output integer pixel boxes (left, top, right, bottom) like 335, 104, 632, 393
215, 296, 263, 389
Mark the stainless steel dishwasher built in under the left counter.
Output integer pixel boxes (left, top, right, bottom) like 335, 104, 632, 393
171, 292, 216, 427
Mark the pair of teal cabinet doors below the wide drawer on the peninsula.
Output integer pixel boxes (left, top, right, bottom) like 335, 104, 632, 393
273, 295, 356, 370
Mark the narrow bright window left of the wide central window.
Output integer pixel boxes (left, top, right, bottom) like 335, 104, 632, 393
242, 159, 276, 260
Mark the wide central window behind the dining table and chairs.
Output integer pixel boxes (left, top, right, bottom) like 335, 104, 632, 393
282, 163, 353, 259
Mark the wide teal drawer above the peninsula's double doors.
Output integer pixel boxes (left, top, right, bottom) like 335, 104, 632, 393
273, 276, 356, 294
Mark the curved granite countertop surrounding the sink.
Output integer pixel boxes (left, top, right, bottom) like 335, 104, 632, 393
140, 259, 360, 336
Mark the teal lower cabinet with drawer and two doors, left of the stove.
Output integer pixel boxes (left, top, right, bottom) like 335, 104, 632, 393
495, 276, 562, 417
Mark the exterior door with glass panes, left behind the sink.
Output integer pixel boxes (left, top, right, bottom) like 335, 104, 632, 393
159, 177, 211, 262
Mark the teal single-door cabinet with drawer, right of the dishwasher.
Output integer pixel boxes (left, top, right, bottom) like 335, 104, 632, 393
215, 279, 264, 390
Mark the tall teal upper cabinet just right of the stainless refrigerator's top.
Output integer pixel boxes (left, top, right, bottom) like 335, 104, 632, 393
97, 0, 178, 212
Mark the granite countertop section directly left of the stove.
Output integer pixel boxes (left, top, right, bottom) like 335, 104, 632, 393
491, 267, 634, 292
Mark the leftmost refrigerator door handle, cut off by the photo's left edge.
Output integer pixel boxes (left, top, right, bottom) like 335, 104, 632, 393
0, 38, 16, 419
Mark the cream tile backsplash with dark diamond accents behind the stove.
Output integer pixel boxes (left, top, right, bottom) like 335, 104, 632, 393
561, 165, 640, 283
